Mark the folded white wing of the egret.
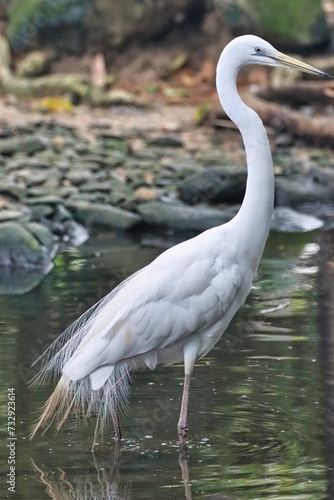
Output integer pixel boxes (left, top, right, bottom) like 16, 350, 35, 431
64, 241, 241, 380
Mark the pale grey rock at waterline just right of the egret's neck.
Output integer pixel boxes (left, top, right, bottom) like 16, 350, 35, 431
270, 207, 324, 233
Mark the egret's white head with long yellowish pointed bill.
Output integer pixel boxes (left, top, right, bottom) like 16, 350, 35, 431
223, 35, 332, 78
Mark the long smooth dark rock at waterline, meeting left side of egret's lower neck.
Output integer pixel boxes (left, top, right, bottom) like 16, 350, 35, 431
138, 201, 239, 233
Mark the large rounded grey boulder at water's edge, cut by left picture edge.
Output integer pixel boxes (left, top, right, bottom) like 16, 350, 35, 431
0, 222, 54, 273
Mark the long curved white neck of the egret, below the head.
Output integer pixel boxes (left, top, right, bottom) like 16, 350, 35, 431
217, 52, 274, 272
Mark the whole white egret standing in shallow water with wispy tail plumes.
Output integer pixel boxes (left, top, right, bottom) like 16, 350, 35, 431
33, 35, 328, 447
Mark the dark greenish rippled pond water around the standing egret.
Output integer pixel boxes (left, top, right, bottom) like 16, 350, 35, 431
0, 233, 334, 500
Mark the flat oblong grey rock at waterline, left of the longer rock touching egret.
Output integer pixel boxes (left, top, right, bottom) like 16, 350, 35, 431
65, 201, 141, 231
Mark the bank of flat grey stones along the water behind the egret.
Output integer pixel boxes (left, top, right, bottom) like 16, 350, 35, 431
0, 100, 334, 293
